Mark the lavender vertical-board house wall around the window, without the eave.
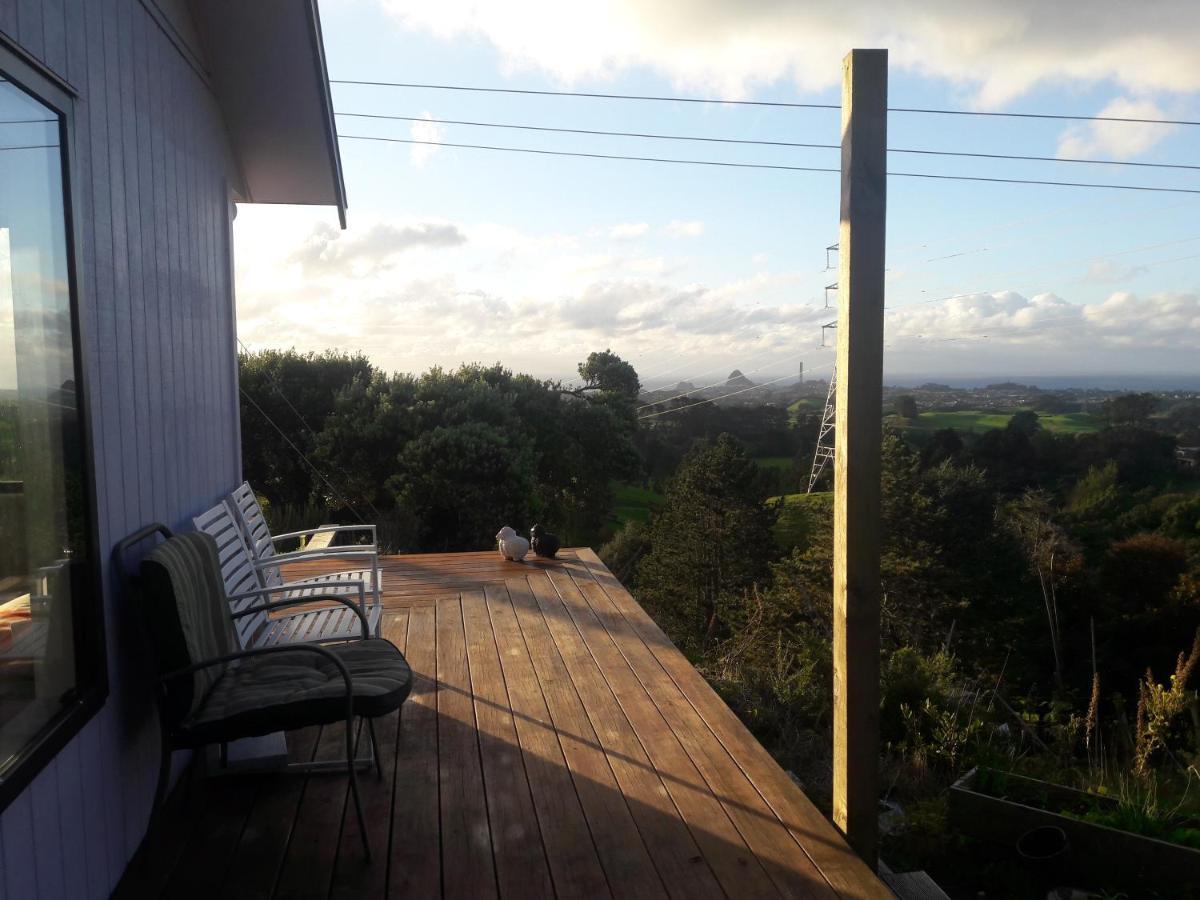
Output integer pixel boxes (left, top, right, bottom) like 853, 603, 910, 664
0, 0, 240, 900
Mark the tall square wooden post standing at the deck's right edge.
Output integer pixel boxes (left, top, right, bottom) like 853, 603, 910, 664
833, 50, 888, 869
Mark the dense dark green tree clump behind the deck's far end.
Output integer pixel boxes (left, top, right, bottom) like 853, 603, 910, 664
242, 353, 637, 551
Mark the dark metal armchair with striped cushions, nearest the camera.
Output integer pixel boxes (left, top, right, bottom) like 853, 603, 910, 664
113, 524, 413, 860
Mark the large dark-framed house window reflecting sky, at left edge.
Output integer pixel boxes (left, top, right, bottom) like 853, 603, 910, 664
0, 47, 106, 806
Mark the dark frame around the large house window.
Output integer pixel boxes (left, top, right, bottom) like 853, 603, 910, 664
0, 32, 108, 814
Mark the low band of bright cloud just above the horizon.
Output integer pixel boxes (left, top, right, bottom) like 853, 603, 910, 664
235, 206, 1200, 382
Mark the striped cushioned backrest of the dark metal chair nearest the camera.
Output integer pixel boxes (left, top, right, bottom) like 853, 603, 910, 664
140, 532, 238, 725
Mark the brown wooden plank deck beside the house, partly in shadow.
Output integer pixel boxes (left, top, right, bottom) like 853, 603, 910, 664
125, 550, 893, 900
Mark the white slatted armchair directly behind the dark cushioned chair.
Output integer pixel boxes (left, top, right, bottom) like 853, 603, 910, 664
192, 500, 383, 647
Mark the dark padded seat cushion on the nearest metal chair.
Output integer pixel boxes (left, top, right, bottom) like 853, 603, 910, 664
175, 638, 413, 746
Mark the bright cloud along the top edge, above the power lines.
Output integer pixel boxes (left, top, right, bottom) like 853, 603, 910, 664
378, 0, 1200, 107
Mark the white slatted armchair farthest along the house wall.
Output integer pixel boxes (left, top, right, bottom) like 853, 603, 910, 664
229, 481, 383, 604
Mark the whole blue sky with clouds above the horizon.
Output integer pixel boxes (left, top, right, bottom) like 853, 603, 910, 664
234, 0, 1200, 386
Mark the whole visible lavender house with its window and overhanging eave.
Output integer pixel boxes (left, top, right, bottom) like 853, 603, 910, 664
0, 0, 346, 900
